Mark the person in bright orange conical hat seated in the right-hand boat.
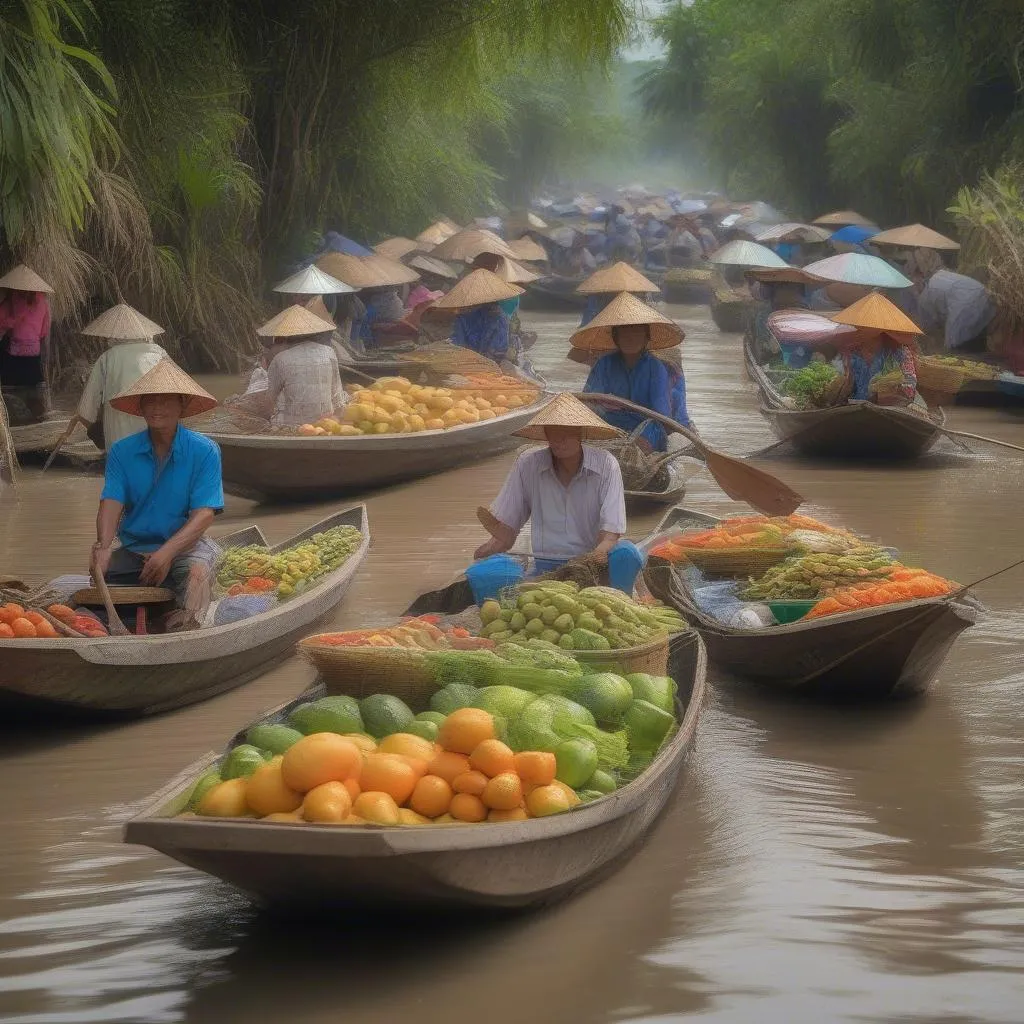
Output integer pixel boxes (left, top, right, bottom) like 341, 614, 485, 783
833, 292, 924, 404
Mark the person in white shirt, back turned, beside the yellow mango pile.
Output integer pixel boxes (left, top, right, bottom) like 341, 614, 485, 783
256, 306, 348, 427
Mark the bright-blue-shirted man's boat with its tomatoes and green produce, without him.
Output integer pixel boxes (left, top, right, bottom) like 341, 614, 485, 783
0, 505, 370, 718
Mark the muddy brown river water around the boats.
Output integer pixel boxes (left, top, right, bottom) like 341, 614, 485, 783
0, 306, 1024, 1024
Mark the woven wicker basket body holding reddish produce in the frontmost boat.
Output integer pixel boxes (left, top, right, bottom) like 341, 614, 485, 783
297, 636, 437, 712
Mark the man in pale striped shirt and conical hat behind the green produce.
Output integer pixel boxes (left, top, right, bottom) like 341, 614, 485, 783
471, 394, 643, 589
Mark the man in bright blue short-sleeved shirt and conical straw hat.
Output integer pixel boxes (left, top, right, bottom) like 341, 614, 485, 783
92, 359, 224, 617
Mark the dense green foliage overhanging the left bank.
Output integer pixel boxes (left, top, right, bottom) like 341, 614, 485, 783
0, 0, 632, 367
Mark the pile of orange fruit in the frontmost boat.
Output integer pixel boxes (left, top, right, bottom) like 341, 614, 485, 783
190, 708, 580, 825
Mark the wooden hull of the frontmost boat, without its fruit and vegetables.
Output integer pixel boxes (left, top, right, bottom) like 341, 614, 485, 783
124, 634, 706, 911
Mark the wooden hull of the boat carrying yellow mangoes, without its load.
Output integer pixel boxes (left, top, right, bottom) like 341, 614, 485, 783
204, 394, 549, 501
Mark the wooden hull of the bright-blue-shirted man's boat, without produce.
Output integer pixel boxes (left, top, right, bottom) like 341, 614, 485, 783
0, 505, 370, 718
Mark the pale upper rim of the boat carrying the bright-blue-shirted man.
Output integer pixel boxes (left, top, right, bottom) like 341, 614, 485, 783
0, 503, 371, 668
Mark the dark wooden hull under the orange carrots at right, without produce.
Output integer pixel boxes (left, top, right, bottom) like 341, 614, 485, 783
644, 508, 983, 700
